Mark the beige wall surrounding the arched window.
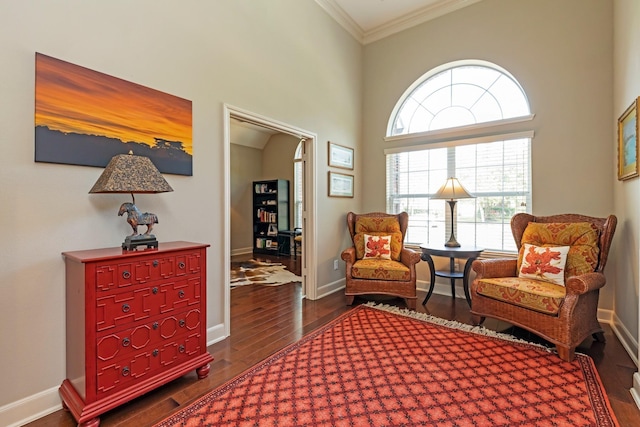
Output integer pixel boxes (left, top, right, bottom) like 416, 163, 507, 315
360, 0, 616, 316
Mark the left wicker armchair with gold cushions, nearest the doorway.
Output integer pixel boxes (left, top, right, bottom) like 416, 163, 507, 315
342, 212, 420, 310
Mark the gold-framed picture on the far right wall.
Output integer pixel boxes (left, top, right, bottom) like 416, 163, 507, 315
618, 98, 638, 181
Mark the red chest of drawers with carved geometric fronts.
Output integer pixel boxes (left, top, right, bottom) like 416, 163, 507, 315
60, 242, 213, 427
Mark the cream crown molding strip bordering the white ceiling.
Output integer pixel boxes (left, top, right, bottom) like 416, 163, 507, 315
315, 0, 482, 44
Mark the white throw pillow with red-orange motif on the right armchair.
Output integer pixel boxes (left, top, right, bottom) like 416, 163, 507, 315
518, 243, 569, 286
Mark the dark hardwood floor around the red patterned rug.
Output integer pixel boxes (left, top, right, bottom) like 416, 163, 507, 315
28, 258, 640, 427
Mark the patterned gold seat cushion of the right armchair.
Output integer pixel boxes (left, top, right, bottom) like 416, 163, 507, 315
476, 277, 566, 315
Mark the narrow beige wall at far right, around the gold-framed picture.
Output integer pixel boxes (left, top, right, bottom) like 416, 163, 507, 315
610, 0, 640, 394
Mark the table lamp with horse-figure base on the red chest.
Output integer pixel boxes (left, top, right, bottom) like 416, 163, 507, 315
89, 151, 173, 250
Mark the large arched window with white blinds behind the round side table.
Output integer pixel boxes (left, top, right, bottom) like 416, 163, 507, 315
385, 61, 533, 252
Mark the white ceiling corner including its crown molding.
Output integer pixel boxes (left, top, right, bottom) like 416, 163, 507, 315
316, 0, 481, 44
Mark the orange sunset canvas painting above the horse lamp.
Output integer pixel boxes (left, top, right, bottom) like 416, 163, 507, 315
35, 53, 193, 175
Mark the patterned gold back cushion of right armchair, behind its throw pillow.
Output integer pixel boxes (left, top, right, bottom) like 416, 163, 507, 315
518, 222, 600, 278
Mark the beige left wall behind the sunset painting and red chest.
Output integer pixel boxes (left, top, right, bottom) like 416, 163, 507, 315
0, 0, 362, 425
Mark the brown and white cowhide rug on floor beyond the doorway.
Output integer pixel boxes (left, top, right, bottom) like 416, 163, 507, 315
231, 259, 302, 289
